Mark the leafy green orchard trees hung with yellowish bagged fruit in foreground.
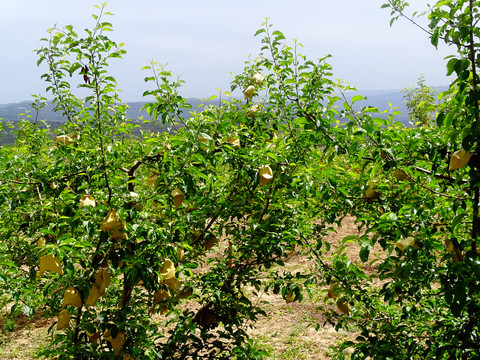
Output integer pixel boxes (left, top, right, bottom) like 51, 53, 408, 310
0, 0, 480, 360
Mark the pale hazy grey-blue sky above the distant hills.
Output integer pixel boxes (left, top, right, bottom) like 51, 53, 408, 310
0, 0, 454, 103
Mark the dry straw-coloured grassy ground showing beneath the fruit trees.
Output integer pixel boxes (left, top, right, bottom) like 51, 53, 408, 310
0, 217, 359, 360
